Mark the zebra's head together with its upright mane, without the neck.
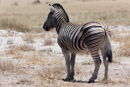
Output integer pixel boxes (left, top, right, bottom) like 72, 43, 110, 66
43, 3, 69, 31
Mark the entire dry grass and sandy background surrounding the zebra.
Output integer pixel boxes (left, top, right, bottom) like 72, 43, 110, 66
0, 0, 130, 87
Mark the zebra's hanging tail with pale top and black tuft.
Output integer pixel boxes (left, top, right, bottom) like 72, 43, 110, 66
106, 28, 113, 63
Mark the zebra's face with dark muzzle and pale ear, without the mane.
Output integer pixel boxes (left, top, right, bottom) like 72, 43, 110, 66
43, 4, 55, 31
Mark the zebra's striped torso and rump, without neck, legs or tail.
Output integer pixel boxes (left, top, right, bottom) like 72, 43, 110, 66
58, 22, 105, 53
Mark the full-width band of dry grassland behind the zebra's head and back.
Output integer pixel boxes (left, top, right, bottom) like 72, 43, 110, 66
0, 0, 130, 32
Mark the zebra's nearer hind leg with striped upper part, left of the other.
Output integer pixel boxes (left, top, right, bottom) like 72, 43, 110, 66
88, 53, 101, 83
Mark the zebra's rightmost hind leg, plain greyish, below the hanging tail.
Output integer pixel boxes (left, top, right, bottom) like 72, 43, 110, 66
101, 49, 108, 80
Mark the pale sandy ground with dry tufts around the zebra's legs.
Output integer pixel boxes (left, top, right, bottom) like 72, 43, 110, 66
0, 26, 130, 87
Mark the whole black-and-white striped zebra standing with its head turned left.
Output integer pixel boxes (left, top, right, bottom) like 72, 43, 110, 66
43, 3, 112, 83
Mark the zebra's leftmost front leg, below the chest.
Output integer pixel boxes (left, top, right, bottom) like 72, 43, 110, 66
62, 50, 71, 81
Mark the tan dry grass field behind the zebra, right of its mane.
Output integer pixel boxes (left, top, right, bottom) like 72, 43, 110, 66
63, 0, 130, 25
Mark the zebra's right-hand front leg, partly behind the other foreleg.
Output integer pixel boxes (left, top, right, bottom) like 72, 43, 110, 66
70, 53, 76, 80
